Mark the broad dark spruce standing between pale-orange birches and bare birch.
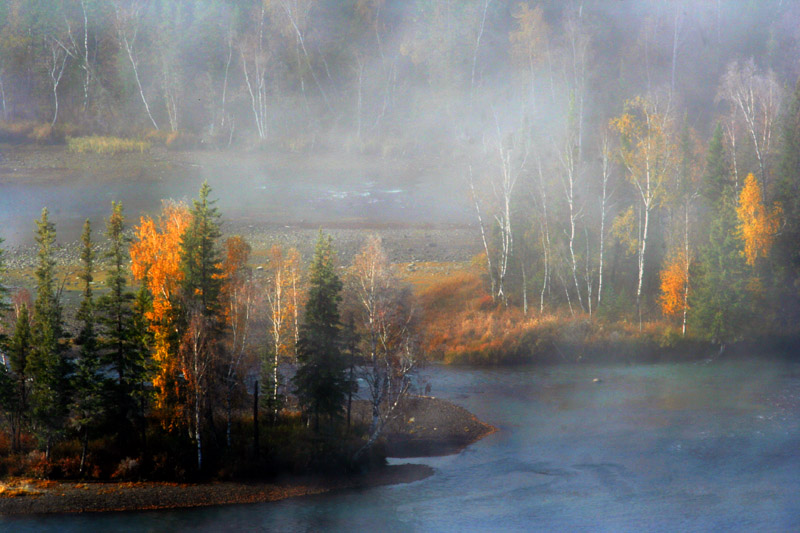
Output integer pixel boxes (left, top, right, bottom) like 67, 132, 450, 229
293, 231, 350, 429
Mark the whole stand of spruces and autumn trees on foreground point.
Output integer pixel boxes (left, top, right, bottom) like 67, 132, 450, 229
0, 184, 420, 476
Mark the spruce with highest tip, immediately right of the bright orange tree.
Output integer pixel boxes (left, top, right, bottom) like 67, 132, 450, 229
181, 181, 222, 317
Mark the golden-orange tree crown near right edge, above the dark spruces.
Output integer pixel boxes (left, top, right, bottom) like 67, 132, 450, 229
736, 173, 783, 266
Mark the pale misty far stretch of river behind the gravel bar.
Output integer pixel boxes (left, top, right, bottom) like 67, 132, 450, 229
0, 162, 473, 246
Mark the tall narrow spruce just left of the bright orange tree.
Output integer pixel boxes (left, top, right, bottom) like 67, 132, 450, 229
98, 202, 143, 434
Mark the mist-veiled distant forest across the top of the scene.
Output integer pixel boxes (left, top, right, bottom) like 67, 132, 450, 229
0, 0, 800, 154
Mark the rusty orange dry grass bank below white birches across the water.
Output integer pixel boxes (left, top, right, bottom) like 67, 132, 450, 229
412, 264, 702, 364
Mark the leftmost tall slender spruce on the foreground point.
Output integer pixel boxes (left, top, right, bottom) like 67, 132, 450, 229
26, 208, 69, 458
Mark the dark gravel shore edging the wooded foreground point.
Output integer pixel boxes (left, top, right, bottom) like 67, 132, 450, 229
0, 397, 497, 517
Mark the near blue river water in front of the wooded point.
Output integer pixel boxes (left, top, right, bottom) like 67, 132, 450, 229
0, 360, 800, 532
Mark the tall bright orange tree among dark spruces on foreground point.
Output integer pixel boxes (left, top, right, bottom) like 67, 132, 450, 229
130, 201, 191, 425
